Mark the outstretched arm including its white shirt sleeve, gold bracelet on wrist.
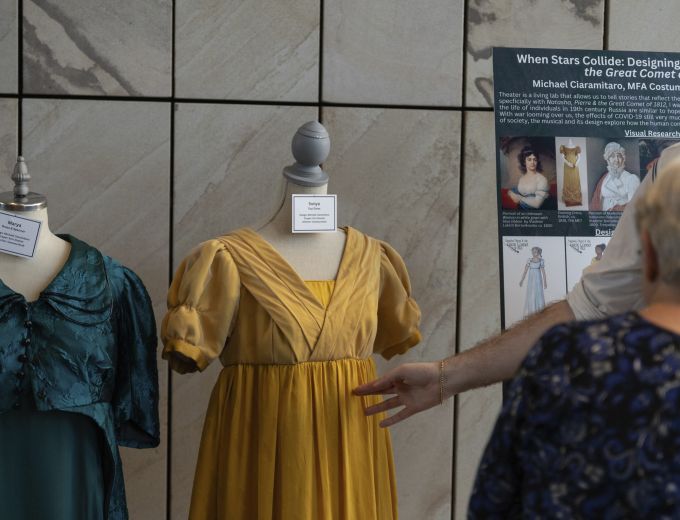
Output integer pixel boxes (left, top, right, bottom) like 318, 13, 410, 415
355, 154, 652, 426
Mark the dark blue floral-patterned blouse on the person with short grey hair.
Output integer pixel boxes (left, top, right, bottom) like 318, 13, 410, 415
468, 312, 680, 519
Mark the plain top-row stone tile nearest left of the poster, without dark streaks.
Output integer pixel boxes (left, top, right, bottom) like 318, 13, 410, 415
323, 0, 463, 106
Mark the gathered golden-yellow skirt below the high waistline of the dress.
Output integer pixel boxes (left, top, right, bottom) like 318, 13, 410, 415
189, 359, 397, 520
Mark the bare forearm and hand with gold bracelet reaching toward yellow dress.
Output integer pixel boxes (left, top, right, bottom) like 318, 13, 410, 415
354, 300, 574, 427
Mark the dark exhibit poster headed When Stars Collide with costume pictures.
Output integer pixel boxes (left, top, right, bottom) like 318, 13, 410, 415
493, 48, 680, 328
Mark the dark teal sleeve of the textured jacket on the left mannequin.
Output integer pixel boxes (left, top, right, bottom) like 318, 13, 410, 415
113, 268, 160, 448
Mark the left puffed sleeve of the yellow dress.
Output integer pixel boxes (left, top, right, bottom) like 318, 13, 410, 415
161, 240, 240, 373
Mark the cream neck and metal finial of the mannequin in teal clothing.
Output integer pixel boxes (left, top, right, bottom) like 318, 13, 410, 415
0, 157, 71, 301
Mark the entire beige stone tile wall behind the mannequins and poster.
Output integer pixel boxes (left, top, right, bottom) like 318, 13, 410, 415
0, 0, 644, 520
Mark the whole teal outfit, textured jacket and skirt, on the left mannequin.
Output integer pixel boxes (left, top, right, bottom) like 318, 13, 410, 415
0, 236, 159, 520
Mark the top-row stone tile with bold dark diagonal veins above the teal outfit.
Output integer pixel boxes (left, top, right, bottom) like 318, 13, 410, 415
23, 0, 172, 96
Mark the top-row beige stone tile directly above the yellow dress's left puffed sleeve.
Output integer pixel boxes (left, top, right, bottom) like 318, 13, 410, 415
176, 0, 321, 101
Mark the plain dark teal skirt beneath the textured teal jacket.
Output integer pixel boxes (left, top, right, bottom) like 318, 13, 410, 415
0, 396, 106, 520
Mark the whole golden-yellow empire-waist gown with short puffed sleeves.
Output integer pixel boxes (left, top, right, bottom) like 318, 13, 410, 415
162, 228, 420, 520
